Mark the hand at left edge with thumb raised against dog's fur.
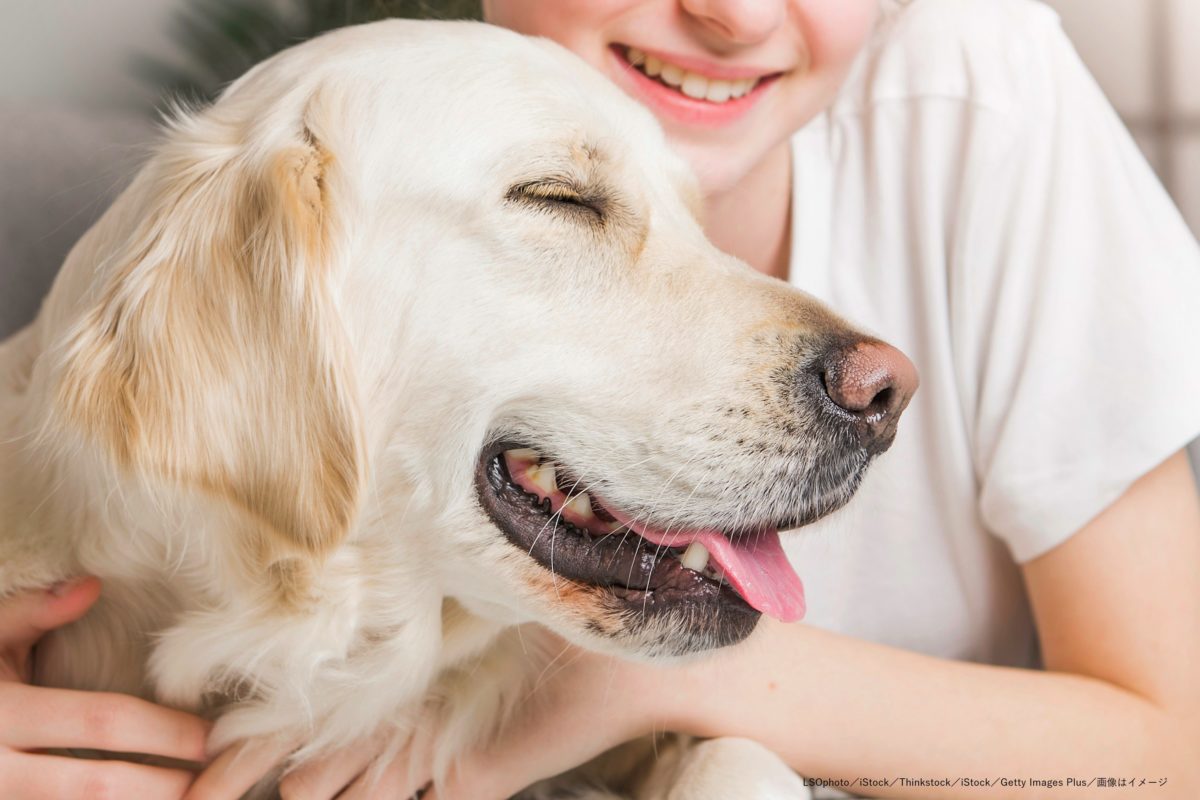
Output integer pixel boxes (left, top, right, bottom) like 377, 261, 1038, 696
0, 578, 209, 800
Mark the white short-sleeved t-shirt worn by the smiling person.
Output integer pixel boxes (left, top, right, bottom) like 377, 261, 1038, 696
785, 0, 1200, 666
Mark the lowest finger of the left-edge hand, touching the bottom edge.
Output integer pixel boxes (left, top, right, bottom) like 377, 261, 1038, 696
0, 752, 193, 800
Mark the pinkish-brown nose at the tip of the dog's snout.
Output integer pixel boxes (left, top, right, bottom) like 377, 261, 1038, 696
814, 339, 919, 455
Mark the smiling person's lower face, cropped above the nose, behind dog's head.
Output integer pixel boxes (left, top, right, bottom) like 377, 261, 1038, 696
484, 0, 878, 196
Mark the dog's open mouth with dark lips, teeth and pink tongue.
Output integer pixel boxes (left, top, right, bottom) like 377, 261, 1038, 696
476, 444, 804, 621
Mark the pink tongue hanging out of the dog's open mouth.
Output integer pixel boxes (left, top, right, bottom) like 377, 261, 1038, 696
609, 521, 804, 622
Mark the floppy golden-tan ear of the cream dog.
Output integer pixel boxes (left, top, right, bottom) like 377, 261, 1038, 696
56, 112, 364, 555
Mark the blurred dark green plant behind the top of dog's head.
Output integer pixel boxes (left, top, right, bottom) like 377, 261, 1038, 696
137, 0, 480, 101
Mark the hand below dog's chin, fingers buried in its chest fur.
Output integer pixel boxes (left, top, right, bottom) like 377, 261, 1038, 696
216, 638, 685, 800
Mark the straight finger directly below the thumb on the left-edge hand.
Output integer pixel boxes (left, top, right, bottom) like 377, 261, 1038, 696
0, 682, 210, 762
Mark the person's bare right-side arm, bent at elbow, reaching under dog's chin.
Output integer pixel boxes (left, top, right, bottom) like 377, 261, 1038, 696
420, 453, 1200, 800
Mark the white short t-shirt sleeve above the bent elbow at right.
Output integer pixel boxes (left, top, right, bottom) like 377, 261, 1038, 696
949, 12, 1200, 563
